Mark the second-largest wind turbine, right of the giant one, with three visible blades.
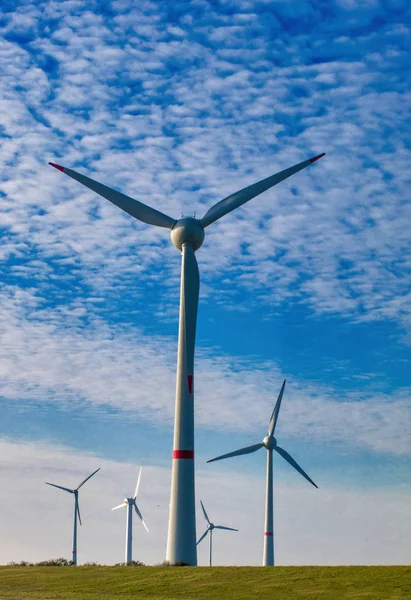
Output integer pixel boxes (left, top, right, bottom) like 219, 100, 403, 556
207, 379, 318, 567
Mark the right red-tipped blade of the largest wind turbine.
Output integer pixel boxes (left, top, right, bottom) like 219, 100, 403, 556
201, 153, 324, 227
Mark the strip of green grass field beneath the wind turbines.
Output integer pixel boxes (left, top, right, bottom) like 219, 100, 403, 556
0, 567, 411, 600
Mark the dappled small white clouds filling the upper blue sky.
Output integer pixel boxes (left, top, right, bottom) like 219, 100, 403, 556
1, 2, 410, 327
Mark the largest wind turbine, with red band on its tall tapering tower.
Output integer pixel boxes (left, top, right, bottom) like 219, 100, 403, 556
50, 154, 324, 565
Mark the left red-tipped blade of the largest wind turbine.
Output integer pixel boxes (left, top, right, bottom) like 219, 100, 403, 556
49, 163, 175, 229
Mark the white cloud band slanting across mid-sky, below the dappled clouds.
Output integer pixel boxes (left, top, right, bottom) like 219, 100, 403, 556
0, 289, 411, 455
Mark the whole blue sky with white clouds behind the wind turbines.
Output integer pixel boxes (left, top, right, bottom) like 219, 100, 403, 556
0, 0, 411, 564
